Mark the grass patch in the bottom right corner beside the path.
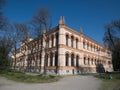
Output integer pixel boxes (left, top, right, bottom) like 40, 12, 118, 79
96, 73, 120, 90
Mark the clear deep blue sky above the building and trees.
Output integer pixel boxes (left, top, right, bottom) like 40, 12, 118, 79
3, 0, 120, 44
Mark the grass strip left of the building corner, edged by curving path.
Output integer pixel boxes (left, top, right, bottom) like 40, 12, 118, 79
0, 70, 61, 83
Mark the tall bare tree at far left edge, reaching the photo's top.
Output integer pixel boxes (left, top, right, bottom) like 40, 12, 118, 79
0, 0, 12, 68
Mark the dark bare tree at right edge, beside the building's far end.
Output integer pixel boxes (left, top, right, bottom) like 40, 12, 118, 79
103, 20, 120, 70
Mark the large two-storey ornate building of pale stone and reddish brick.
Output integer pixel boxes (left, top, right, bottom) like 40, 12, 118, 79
13, 17, 113, 75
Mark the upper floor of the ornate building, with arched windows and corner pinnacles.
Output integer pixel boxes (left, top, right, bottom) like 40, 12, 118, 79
14, 17, 111, 58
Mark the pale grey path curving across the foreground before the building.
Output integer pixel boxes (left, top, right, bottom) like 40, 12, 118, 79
0, 75, 101, 90
